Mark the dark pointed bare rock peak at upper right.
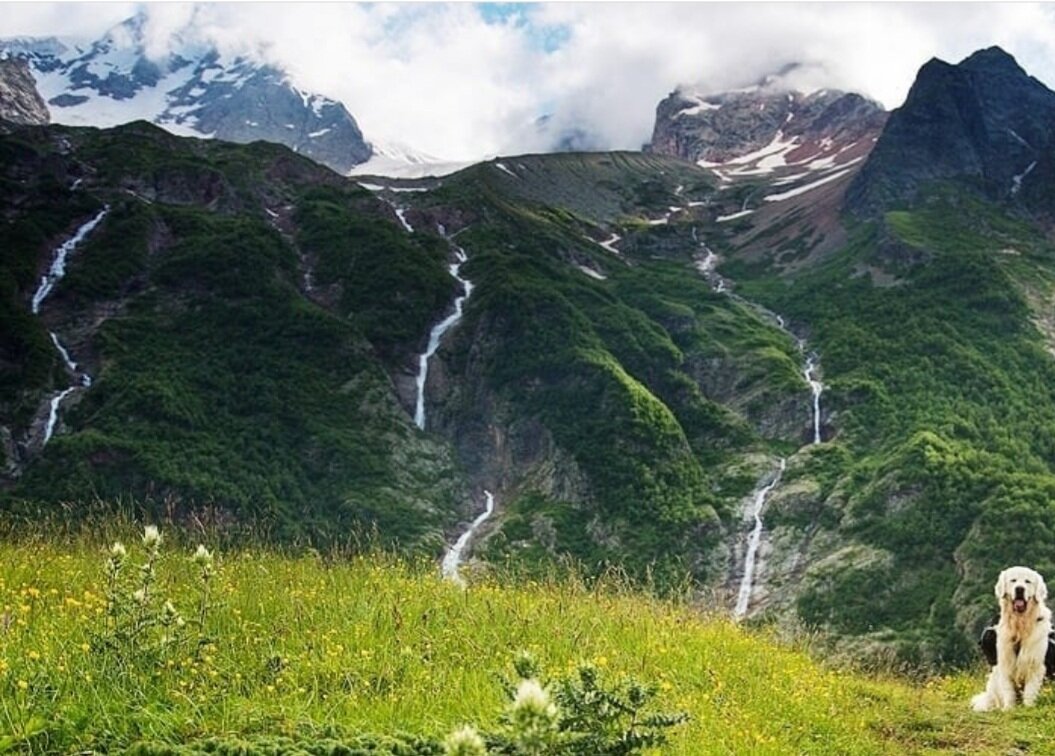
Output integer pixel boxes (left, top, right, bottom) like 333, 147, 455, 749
847, 47, 1055, 214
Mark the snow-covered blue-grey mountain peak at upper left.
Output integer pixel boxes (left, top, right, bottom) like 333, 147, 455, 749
0, 15, 371, 173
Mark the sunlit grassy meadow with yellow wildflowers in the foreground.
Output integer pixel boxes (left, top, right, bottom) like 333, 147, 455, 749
0, 541, 1038, 754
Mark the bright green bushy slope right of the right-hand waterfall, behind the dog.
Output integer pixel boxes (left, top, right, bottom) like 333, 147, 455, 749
721, 185, 1055, 661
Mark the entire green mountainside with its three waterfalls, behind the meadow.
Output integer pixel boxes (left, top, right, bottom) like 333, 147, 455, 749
6, 41, 1055, 667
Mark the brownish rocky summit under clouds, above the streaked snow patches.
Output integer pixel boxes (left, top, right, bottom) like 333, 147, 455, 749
649, 74, 887, 164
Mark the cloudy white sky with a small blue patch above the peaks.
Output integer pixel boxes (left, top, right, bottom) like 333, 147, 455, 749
6, 2, 1055, 159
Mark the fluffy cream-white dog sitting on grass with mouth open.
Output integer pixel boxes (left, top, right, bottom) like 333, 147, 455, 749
971, 567, 1052, 712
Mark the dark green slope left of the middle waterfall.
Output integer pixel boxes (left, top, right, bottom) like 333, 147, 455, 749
3, 124, 464, 551
